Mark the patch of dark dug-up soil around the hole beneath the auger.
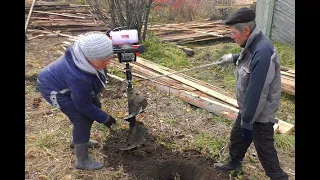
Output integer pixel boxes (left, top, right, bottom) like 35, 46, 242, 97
103, 131, 228, 180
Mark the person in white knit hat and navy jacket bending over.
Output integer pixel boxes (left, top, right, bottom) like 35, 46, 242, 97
37, 32, 116, 170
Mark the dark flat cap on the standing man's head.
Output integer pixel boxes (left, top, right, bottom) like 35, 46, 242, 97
224, 7, 256, 25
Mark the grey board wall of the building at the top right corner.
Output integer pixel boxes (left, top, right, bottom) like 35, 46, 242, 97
270, 0, 295, 45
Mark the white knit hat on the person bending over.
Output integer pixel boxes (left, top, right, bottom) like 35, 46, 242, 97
78, 32, 114, 60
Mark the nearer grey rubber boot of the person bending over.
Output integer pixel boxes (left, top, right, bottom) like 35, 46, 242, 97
75, 142, 104, 170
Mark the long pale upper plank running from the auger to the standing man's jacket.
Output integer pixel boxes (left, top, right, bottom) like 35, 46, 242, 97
137, 57, 238, 107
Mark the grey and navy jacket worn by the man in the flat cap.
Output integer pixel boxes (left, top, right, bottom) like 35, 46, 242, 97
233, 28, 281, 130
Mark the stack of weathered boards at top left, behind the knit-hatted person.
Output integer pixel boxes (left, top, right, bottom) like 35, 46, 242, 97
25, 1, 108, 37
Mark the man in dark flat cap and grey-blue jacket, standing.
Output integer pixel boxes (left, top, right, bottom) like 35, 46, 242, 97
214, 8, 288, 180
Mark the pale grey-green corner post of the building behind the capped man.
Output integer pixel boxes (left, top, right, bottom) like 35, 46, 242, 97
256, 0, 274, 38
